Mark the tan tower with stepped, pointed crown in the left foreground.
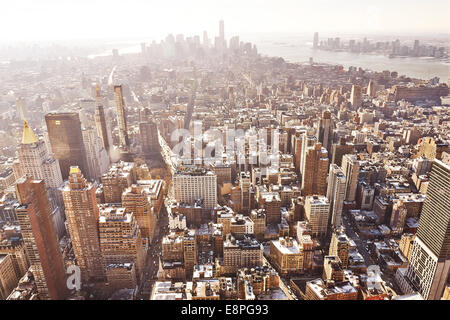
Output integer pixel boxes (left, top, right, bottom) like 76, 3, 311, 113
62, 166, 105, 283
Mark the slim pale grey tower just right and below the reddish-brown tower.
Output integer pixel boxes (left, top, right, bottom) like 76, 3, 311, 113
327, 164, 345, 227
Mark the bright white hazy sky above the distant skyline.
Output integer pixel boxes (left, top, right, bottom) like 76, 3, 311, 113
0, 0, 450, 42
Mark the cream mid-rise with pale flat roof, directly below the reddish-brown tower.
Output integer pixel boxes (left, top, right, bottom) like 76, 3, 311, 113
305, 196, 330, 238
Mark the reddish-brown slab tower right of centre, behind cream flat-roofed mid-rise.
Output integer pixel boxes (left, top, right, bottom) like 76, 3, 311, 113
302, 143, 329, 196
